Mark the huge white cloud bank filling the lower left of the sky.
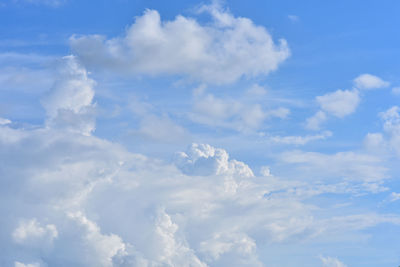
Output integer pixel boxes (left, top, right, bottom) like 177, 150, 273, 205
0, 120, 400, 266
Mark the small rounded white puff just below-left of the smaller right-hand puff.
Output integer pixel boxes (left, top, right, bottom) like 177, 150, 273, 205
316, 90, 360, 118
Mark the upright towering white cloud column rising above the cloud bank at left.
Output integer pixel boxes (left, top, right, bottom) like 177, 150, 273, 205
42, 56, 95, 135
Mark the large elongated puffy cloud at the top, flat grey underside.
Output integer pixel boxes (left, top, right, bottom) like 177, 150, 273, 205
70, 5, 289, 84
